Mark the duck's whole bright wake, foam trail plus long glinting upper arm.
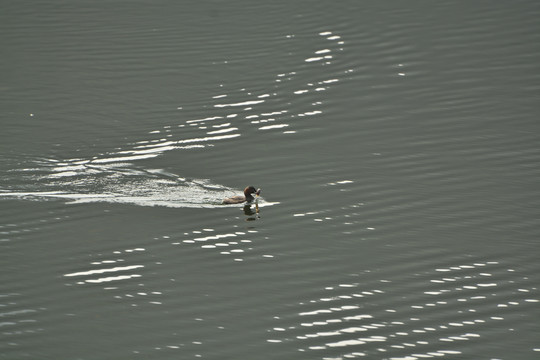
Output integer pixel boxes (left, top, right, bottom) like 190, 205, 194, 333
0, 31, 344, 211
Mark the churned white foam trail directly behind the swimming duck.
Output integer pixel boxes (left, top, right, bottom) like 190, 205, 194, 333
0, 164, 277, 208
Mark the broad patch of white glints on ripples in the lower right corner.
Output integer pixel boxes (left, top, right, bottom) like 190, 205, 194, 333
267, 261, 540, 359
